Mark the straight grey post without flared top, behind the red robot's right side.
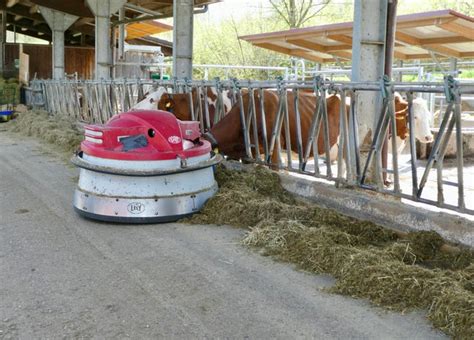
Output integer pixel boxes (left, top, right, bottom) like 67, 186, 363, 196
173, 0, 194, 79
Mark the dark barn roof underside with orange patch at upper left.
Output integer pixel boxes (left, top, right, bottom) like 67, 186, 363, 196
0, 0, 221, 49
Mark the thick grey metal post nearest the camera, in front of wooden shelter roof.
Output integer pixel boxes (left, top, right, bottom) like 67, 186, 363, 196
351, 0, 388, 147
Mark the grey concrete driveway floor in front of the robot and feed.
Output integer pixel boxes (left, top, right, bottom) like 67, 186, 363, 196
0, 129, 446, 339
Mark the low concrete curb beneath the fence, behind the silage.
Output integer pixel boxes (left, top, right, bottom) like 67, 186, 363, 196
279, 172, 474, 247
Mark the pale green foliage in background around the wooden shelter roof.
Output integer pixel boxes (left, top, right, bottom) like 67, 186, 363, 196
193, 0, 474, 80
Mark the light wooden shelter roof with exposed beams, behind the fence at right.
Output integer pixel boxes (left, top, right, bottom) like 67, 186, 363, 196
239, 9, 474, 63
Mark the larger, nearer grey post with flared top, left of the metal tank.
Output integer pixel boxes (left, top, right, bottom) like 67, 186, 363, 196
87, 0, 127, 79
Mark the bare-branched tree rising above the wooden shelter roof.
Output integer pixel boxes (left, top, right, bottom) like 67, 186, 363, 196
270, 0, 331, 28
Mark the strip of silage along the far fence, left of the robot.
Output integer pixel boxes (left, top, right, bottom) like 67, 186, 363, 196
10, 111, 84, 154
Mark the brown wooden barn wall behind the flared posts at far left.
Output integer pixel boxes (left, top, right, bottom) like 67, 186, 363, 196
5, 44, 94, 79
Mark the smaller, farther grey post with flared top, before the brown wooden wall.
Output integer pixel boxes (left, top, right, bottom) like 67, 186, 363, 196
40, 6, 79, 79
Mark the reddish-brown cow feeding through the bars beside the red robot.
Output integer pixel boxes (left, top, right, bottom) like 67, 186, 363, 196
203, 90, 341, 165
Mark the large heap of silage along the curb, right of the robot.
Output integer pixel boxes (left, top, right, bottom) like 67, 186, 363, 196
191, 167, 474, 339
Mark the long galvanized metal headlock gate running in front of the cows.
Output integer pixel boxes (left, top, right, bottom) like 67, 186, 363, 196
31, 76, 474, 214
